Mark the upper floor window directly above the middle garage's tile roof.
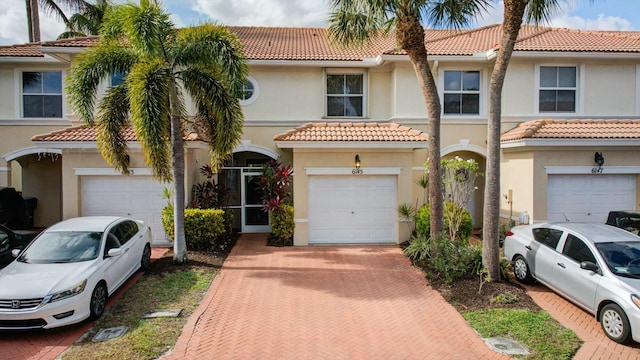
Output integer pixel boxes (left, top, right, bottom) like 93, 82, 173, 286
327, 74, 365, 117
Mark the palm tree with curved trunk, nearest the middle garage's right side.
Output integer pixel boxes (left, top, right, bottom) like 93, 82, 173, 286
329, 0, 490, 236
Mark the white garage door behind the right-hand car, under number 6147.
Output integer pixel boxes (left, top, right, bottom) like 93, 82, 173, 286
547, 175, 636, 222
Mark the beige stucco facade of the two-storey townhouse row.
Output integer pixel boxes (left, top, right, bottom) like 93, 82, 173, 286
0, 27, 640, 245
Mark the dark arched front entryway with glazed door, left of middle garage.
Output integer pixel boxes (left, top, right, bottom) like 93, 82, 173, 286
218, 151, 274, 233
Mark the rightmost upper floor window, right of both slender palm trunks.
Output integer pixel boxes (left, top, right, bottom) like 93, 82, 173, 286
538, 66, 578, 112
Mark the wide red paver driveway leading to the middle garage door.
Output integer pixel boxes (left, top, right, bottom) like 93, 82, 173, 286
167, 234, 508, 360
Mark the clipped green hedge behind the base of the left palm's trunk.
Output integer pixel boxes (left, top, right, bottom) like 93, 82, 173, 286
162, 206, 225, 250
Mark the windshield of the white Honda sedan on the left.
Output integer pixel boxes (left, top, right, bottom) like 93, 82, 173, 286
17, 231, 102, 264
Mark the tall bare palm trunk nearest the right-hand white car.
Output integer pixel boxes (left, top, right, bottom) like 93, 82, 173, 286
482, 0, 527, 281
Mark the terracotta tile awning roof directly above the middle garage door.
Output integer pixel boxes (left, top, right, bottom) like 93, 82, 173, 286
273, 122, 428, 142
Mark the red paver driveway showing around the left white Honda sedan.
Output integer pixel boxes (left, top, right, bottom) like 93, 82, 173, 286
0, 248, 168, 360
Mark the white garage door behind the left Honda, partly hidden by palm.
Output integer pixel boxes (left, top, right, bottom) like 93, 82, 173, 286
82, 176, 169, 245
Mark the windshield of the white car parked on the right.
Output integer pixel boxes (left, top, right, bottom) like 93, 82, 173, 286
595, 241, 640, 278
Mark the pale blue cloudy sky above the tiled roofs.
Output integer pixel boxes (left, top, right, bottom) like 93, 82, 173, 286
0, 0, 640, 45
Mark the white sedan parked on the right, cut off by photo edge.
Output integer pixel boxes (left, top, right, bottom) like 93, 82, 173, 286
504, 222, 640, 343
